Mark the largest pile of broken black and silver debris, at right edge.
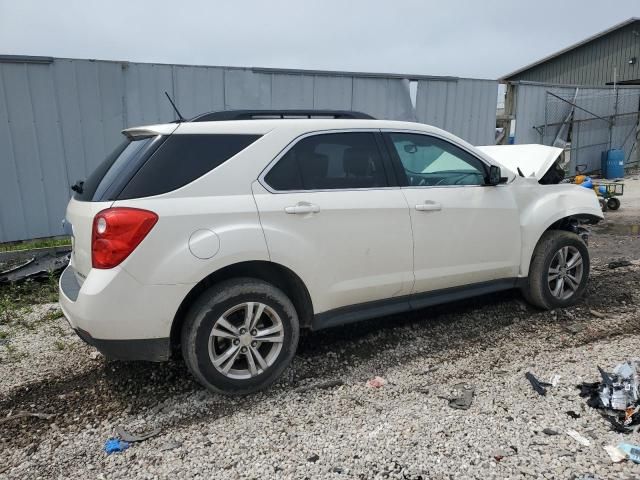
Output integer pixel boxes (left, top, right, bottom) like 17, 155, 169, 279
578, 360, 640, 433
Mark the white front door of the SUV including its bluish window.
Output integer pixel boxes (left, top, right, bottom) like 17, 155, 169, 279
385, 132, 520, 293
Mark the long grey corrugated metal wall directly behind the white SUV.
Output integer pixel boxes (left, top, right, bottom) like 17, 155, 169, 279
0, 57, 498, 242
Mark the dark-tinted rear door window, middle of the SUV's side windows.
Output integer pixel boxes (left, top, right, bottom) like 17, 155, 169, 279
265, 132, 387, 190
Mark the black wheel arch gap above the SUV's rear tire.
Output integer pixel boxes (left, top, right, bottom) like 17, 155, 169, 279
170, 260, 313, 351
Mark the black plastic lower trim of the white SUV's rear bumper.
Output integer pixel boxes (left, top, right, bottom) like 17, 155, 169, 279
75, 328, 170, 362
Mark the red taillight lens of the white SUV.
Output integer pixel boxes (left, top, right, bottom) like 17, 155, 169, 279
91, 207, 158, 268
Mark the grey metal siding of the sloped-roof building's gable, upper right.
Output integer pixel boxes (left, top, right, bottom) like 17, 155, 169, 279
505, 22, 640, 86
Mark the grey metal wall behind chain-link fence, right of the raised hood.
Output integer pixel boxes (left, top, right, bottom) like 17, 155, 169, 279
511, 82, 640, 173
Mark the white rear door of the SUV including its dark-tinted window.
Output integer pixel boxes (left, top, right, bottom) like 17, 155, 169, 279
253, 131, 413, 313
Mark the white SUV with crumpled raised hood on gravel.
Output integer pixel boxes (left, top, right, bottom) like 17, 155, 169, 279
60, 111, 602, 393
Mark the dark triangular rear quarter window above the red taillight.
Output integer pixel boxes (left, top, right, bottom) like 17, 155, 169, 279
118, 134, 260, 200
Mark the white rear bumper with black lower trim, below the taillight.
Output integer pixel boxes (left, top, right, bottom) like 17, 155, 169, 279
59, 265, 191, 361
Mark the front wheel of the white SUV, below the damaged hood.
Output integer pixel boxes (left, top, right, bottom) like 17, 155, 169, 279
522, 230, 590, 310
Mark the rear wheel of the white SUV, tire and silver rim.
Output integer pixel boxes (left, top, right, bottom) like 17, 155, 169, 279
181, 278, 300, 395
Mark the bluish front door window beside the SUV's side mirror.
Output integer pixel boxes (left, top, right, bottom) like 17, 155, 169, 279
389, 133, 486, 186
